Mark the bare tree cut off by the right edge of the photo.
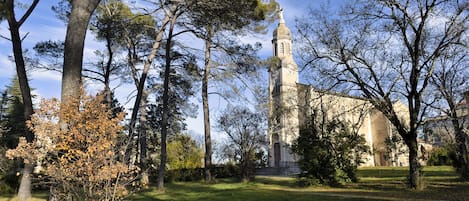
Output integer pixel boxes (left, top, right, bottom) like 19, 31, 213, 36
431, 43, 469, 179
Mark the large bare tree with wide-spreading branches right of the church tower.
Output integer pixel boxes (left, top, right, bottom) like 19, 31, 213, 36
298, 0, 469, 189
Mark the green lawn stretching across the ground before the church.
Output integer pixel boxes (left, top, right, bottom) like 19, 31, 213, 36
0, 167, 469, 201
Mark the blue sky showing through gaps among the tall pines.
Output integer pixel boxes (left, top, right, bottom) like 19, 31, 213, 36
0, 0, 341, 144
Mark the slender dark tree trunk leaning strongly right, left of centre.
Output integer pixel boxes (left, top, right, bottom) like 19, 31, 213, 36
124, 15, 170, 162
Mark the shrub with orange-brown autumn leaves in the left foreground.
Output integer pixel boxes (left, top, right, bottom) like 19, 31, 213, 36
7, 93, 135, 200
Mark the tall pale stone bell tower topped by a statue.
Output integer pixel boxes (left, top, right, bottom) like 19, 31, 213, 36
269, 9, 299, 173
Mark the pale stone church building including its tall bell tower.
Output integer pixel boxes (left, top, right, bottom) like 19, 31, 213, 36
268, 11, 408, 174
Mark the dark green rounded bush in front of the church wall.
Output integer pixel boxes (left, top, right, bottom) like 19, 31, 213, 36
292, 114, 368, 186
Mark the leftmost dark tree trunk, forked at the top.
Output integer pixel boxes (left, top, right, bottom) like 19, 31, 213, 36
5, 0, 39, 201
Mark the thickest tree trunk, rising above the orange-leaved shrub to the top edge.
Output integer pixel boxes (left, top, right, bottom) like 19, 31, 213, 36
62, 0, 100, 103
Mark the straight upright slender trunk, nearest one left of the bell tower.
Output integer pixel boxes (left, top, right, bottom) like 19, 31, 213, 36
202, 27, 213, 182
